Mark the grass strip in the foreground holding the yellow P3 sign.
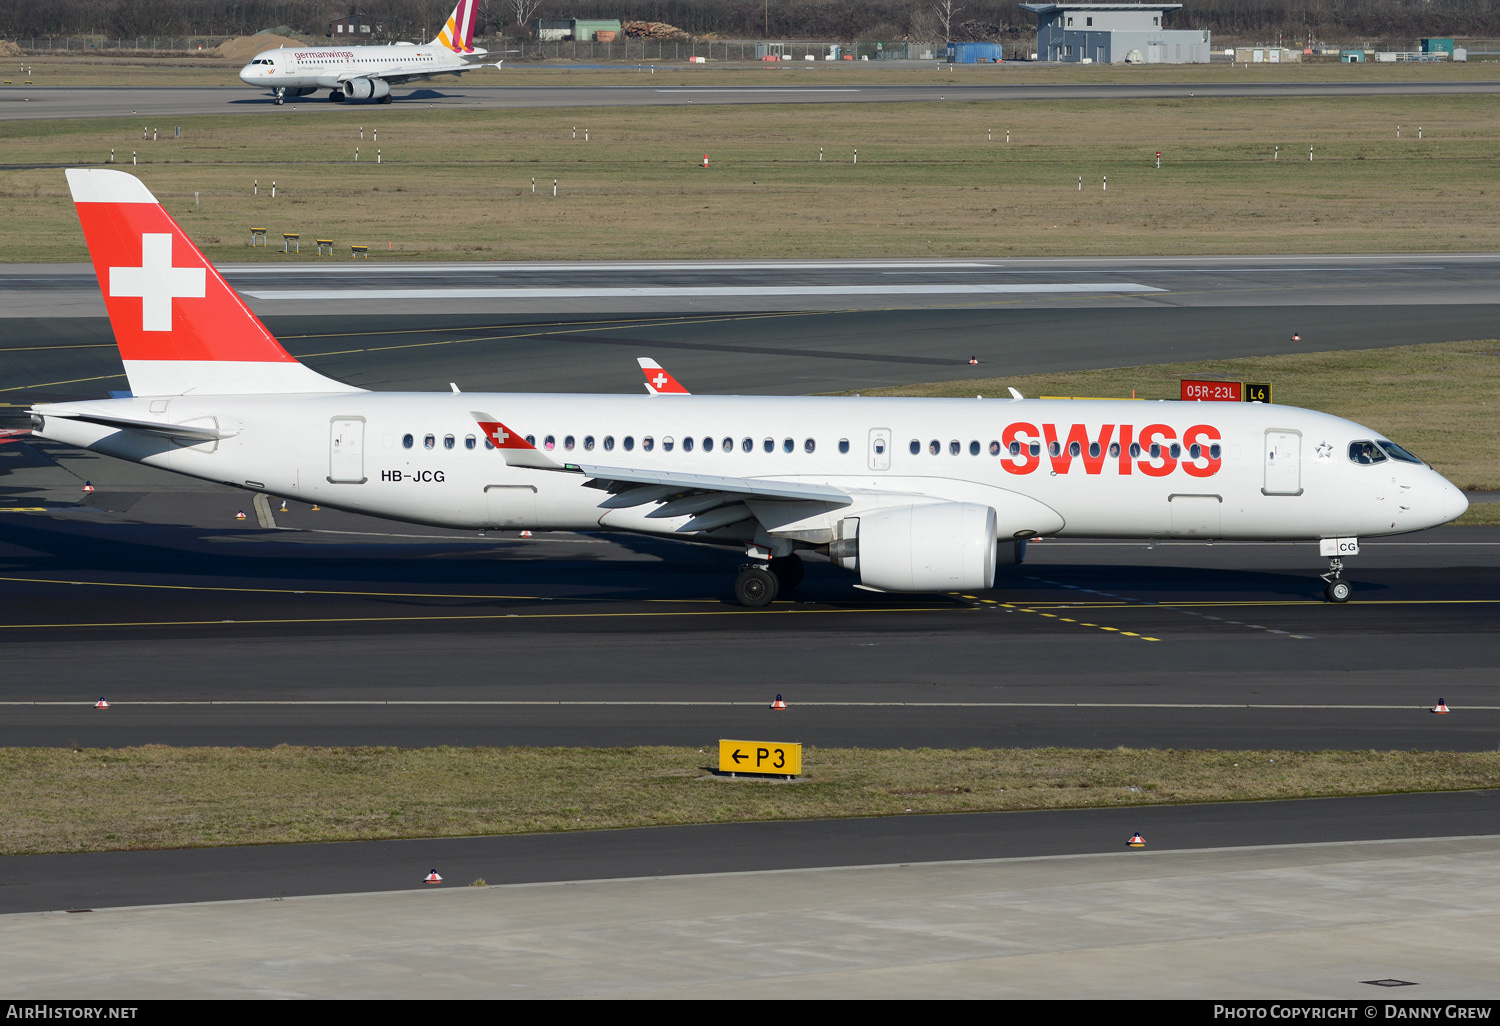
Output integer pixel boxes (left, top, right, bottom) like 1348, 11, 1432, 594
0, 744, 1500, 855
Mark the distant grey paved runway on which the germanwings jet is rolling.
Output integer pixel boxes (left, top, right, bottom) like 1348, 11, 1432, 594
0, 79, 1500, 120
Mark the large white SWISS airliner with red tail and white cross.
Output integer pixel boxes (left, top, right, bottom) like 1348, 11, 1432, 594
32, 170, 1467, 606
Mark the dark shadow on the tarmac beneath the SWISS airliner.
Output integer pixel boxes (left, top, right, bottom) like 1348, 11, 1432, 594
0, 515, 1362, 608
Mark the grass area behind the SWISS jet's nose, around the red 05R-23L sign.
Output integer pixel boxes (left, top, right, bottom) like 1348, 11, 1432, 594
863, 339, 1500, 501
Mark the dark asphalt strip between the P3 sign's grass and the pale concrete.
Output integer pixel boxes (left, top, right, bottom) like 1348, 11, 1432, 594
0, 785, 1500, 915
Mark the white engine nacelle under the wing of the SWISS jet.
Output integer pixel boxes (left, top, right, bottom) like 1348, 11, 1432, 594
830, 503, 996, 591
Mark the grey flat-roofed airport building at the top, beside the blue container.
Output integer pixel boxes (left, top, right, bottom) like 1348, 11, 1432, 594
1020, 3, 1209, 65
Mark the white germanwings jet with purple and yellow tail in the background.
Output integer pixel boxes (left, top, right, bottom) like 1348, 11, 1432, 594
240, 0, 504, 104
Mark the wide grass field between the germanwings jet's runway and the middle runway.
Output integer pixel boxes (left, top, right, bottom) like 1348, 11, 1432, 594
0, 96, 1500, 263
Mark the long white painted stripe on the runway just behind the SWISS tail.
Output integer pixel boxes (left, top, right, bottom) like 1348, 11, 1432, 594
246, 282, 1166, 302
